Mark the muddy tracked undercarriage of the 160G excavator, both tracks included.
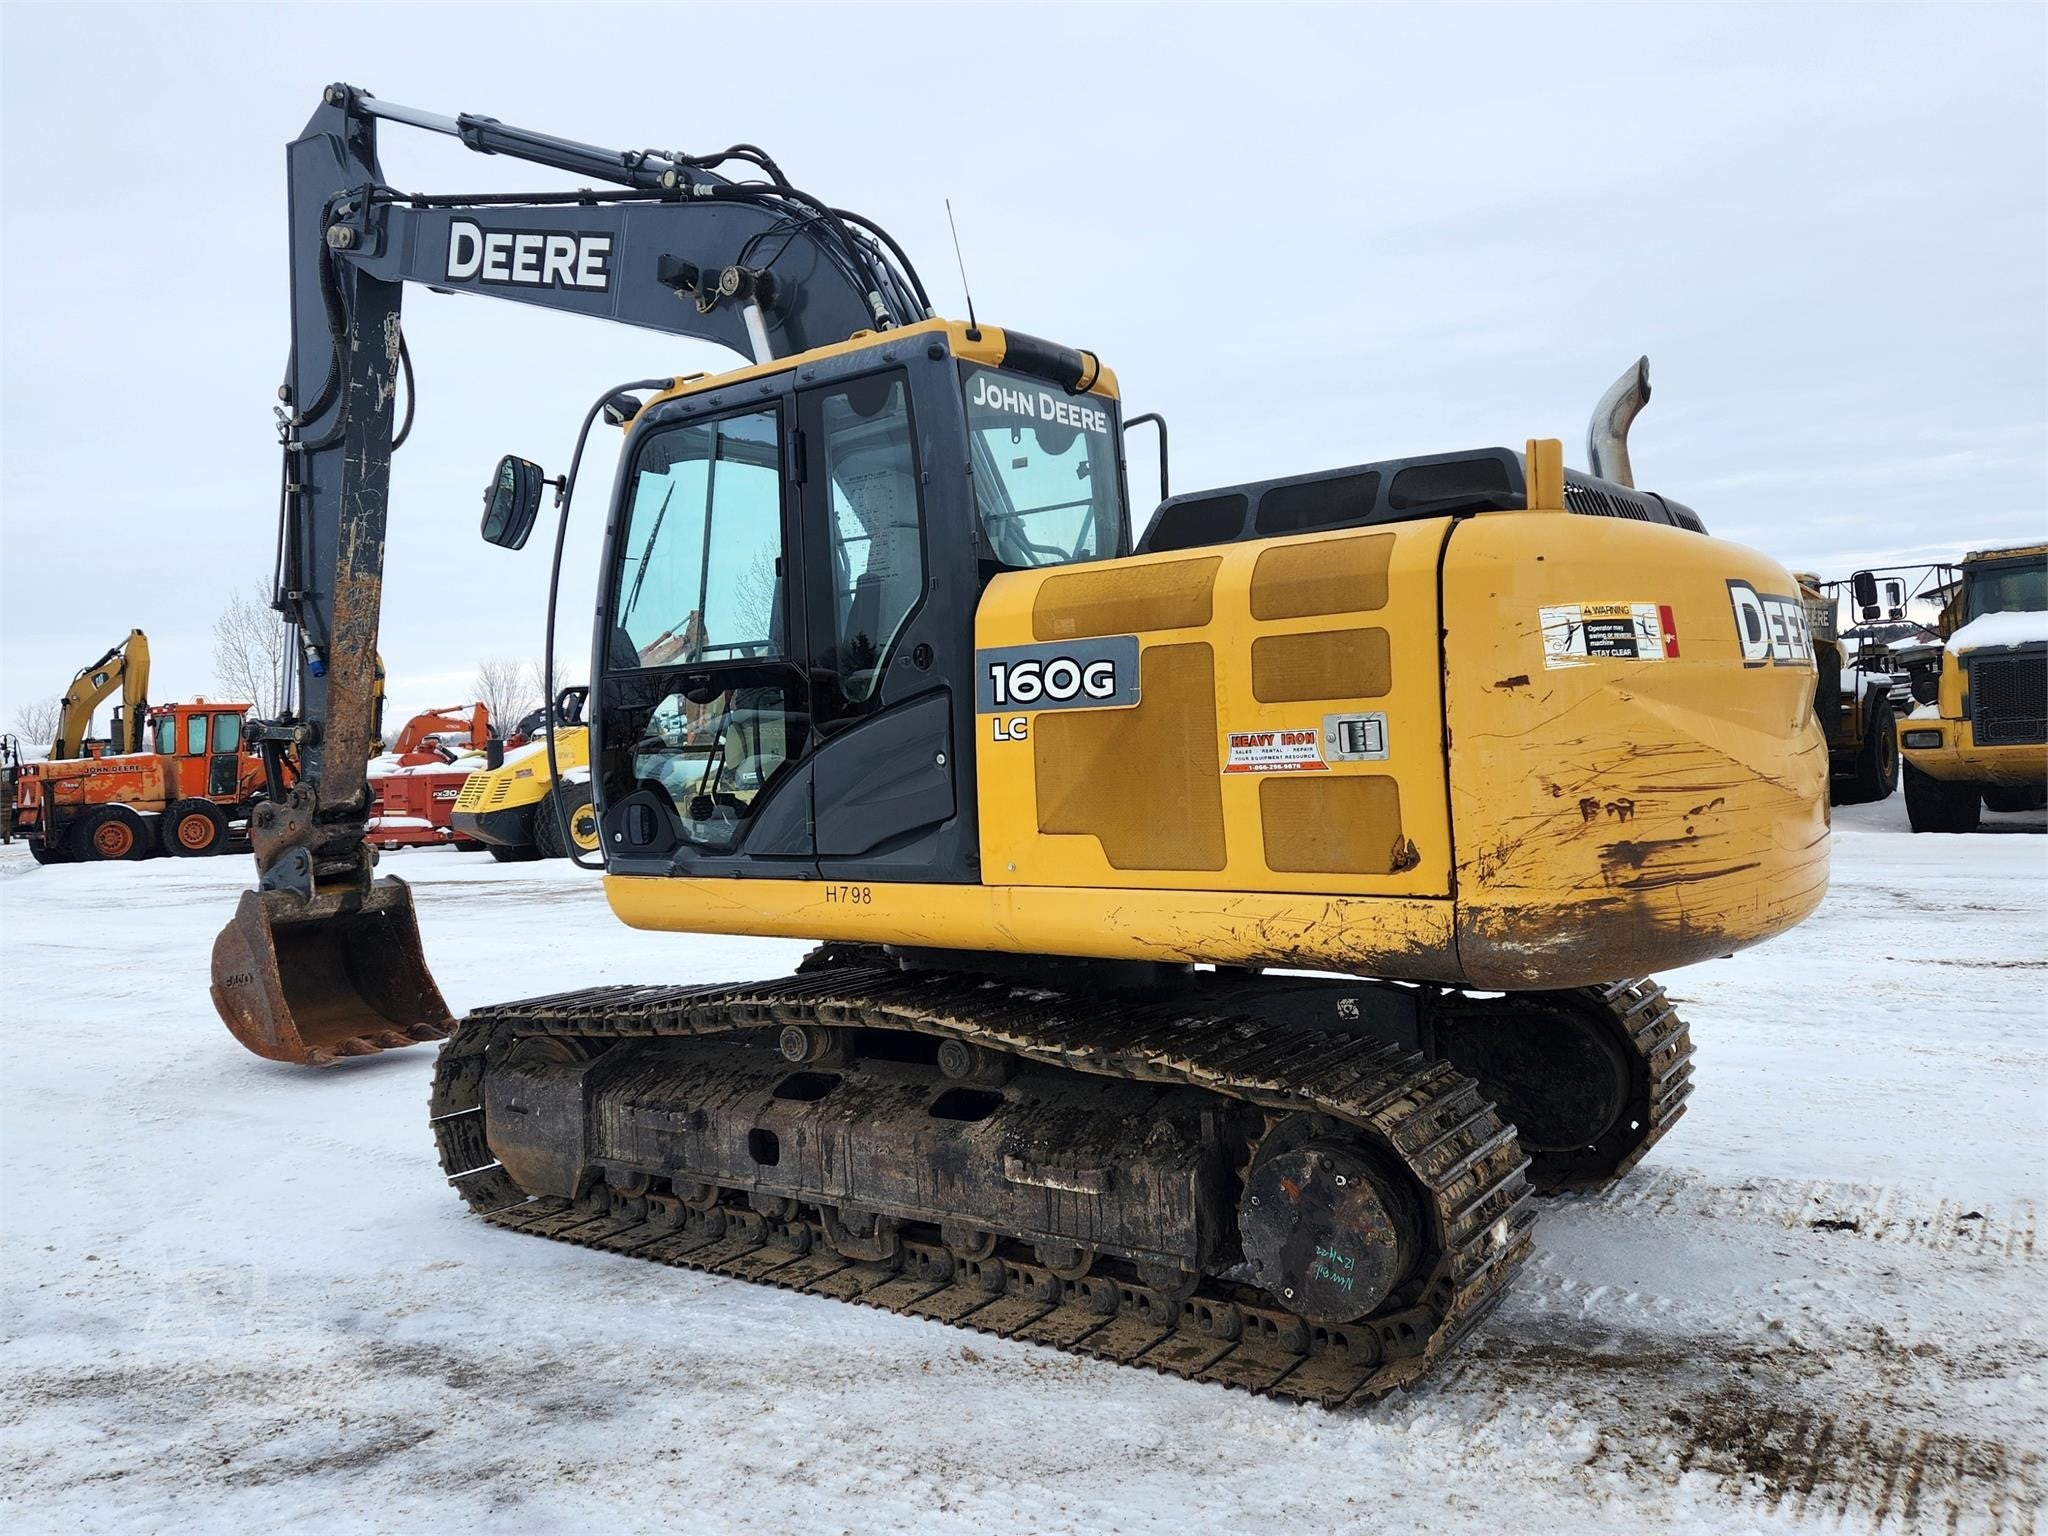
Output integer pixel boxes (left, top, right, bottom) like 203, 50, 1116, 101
432, 962, 1690, 1405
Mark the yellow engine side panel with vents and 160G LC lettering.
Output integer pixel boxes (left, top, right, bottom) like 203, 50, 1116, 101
975, 518, 1452, 897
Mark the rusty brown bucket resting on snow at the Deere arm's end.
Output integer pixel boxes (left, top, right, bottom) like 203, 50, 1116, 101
213, 879, 455, 1067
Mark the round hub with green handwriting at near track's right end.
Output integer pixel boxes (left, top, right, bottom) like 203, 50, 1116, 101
1237, 1141, 1421, 1327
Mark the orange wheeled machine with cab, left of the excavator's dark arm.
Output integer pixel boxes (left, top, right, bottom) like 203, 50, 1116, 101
8, 698, 276, 864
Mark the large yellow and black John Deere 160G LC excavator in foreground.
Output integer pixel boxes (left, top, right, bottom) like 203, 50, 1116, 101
213, 86, 1829, 1403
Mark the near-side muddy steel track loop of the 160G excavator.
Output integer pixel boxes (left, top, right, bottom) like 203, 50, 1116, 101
432, 965, 1534, 1407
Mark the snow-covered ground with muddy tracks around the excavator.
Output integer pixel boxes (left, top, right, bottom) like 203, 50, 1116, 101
0, 797, 2048, 1536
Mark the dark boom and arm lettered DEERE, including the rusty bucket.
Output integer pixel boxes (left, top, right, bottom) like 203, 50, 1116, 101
213, 84, 930, 1065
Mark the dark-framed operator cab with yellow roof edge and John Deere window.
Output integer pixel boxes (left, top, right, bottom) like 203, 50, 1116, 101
487, 322, 1130, 883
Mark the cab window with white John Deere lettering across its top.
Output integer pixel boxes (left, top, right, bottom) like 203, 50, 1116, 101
961, 367, 1124, 567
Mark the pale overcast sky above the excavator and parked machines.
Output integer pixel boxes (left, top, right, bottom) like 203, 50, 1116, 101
0, 0, 2048, 729
